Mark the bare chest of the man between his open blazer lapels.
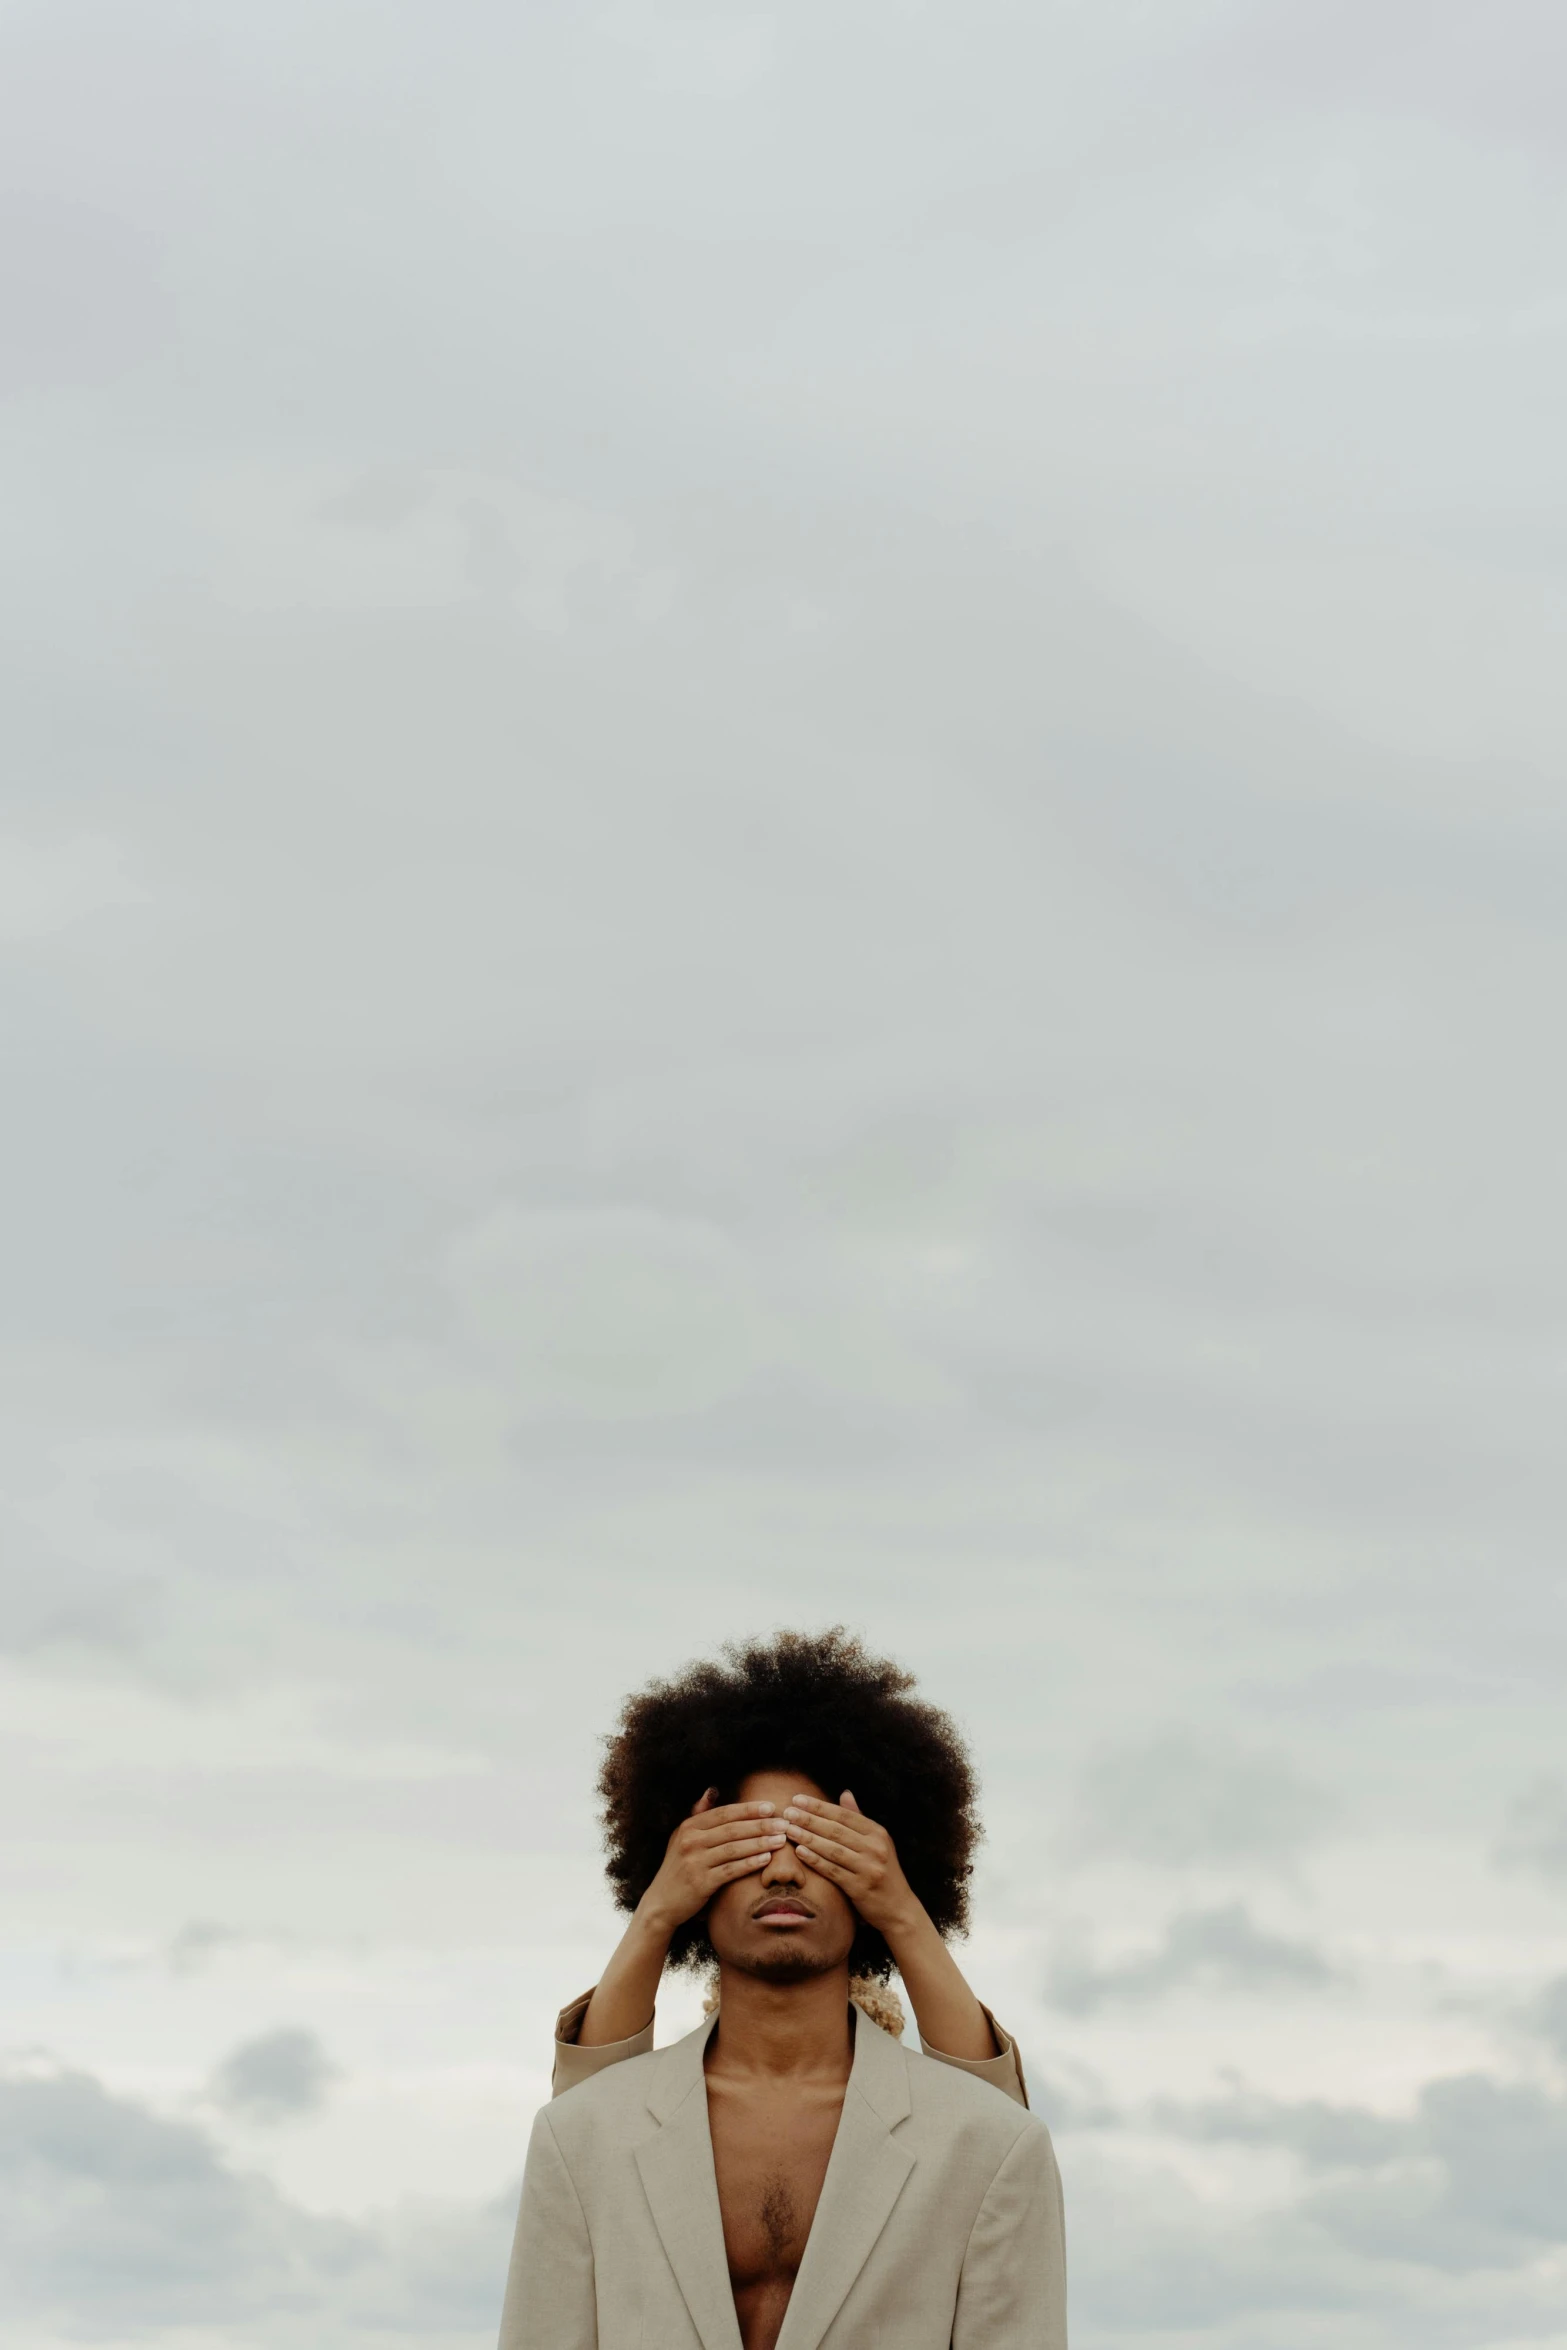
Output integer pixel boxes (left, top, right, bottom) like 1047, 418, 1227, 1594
707, 2080, 843, 2350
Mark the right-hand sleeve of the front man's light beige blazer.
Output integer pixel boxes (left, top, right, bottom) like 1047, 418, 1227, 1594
951, 2120, 1067, 2350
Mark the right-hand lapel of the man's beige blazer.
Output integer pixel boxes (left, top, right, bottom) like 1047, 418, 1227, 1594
775, 2014, 914, 2350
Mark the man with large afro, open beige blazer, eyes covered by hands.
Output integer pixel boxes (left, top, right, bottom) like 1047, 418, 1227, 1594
500, 1631, 1067, 2350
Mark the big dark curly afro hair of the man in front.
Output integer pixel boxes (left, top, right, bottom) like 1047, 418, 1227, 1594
599, 1624, 982, 1981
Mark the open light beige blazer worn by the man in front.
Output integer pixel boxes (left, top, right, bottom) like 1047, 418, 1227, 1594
500, 2014, 1067, 2350
